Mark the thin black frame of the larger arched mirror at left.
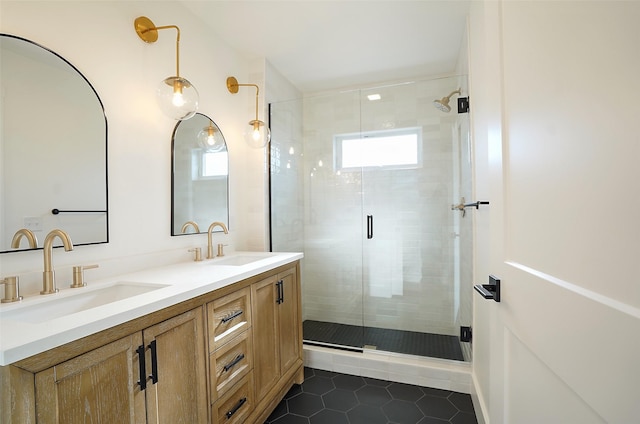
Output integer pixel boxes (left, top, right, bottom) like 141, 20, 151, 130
0, 32, 109, 254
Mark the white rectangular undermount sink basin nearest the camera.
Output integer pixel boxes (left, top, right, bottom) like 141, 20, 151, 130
0, 281, 167, 323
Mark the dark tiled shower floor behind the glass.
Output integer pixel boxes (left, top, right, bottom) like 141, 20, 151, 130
302, 320, 464, 361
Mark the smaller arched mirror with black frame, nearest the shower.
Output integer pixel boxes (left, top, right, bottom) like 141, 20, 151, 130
171, 113, 229, 236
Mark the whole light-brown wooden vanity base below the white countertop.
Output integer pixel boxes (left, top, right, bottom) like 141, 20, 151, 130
0, 262, 304, 424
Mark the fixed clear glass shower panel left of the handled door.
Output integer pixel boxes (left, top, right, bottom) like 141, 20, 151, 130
270, 92, 364, 350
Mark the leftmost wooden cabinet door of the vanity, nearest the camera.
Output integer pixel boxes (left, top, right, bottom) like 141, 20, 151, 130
36, 333, 146, 424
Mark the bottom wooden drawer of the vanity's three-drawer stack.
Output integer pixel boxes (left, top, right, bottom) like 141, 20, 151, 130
211, 372, 255, 424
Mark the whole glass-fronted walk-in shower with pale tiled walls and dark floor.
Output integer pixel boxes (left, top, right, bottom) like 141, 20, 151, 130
270, 76, 473, 360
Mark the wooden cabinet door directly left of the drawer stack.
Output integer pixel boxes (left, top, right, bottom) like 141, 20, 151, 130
143, 308, 209, 424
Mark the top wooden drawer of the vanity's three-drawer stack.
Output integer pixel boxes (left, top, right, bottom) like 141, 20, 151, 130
207, 287, 251, 352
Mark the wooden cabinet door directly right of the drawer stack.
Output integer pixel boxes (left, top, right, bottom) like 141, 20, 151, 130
251, 275, 280, 399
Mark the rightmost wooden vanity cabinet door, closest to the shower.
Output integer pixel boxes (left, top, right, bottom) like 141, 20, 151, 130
278, 268, 301, 374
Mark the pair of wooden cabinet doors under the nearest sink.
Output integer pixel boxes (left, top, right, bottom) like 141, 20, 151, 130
35, 308, 208, 424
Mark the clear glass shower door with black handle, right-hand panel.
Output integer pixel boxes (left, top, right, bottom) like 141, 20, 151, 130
361, 78, 468, 360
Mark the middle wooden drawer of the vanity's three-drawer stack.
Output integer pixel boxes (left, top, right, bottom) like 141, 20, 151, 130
209, 330, 253, 402
